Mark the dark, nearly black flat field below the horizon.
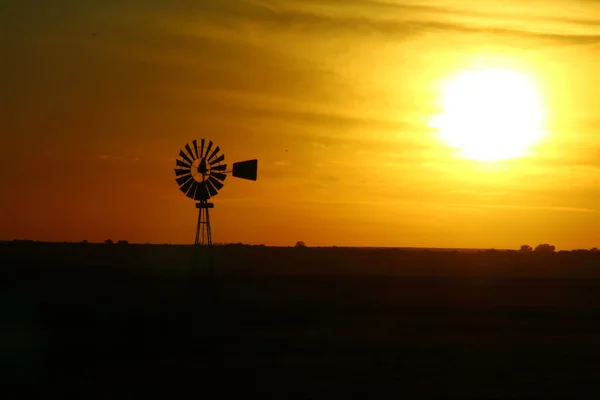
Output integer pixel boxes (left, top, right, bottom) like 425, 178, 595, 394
0, 243, 600, 399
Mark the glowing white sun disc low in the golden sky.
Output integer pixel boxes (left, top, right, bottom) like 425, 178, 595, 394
430, 68, 545, 161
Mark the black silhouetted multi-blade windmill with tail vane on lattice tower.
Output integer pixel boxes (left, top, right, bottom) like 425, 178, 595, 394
175, 139, 258, 246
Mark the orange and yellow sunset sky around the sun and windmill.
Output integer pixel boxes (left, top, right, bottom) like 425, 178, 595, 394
0, 0, 600, 249
